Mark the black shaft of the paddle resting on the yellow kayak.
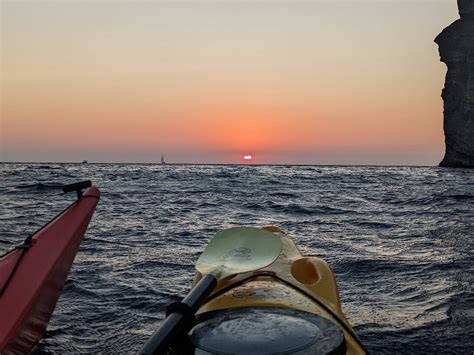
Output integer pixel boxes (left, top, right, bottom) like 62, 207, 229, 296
139, 274, 217, 354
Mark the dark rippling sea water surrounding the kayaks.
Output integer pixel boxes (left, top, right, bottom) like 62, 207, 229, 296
0, 164, 474, 354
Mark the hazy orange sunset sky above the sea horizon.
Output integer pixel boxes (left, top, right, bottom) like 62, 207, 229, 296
0, 0, 459, 165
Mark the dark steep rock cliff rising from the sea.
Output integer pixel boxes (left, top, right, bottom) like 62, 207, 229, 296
435, 0, 474, 168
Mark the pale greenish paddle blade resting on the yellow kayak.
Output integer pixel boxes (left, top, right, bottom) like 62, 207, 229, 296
196, 227, 282, 281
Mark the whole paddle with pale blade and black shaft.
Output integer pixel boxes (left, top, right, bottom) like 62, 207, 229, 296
140, 227, 282, 354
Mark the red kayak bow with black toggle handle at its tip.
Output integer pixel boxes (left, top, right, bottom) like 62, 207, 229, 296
0, 182, 100, 354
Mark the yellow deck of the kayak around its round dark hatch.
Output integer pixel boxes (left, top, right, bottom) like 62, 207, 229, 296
190, 227, 366, 354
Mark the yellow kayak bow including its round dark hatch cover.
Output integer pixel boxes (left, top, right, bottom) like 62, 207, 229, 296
141, 227, 368, 354
